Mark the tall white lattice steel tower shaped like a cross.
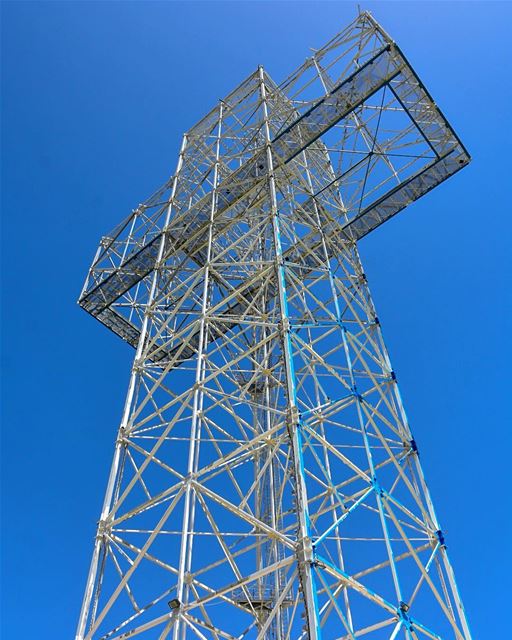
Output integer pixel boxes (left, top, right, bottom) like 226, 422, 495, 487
77, 13, 470, 640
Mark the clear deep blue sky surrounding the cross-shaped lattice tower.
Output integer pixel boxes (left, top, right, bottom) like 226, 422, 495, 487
2, 1, 512, 640
